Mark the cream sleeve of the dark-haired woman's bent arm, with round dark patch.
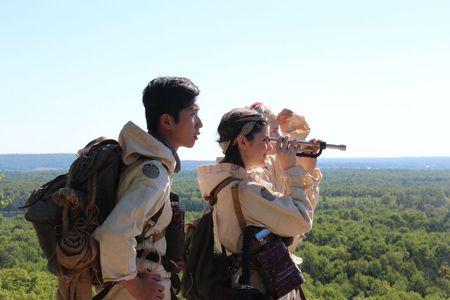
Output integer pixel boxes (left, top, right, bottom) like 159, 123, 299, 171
239, 166, 316, 236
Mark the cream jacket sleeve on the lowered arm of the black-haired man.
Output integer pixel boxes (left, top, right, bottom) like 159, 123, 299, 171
94, 163, 169, 281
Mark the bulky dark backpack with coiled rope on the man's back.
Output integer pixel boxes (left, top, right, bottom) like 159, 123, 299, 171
23, 137, 123, 299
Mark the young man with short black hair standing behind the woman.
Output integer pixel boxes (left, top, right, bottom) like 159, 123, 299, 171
94, 77, 203, 299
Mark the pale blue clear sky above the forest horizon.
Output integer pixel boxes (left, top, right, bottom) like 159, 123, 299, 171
0, 0, 450, 160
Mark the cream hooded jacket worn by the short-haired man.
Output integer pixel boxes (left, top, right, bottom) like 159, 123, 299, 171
94, 122, 176, 281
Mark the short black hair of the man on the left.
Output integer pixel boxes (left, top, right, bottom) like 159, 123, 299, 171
142, 77, 200, 132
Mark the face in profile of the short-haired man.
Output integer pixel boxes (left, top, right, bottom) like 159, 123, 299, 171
171, 101, 203, 149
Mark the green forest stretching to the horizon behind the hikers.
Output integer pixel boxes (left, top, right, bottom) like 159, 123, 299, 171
0, 169, 450, 300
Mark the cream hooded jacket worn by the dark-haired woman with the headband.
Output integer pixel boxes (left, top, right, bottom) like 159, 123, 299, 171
198, 163, 320, 253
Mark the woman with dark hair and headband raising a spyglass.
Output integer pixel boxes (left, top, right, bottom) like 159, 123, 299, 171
198, 108, 318, 299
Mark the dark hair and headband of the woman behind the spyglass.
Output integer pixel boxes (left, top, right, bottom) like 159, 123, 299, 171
217, 108, 267, 167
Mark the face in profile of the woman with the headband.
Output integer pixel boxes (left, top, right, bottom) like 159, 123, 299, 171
241, 126, 273, 170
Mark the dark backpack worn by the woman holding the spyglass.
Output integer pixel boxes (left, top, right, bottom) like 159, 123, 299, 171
181, 177, 240, 300
